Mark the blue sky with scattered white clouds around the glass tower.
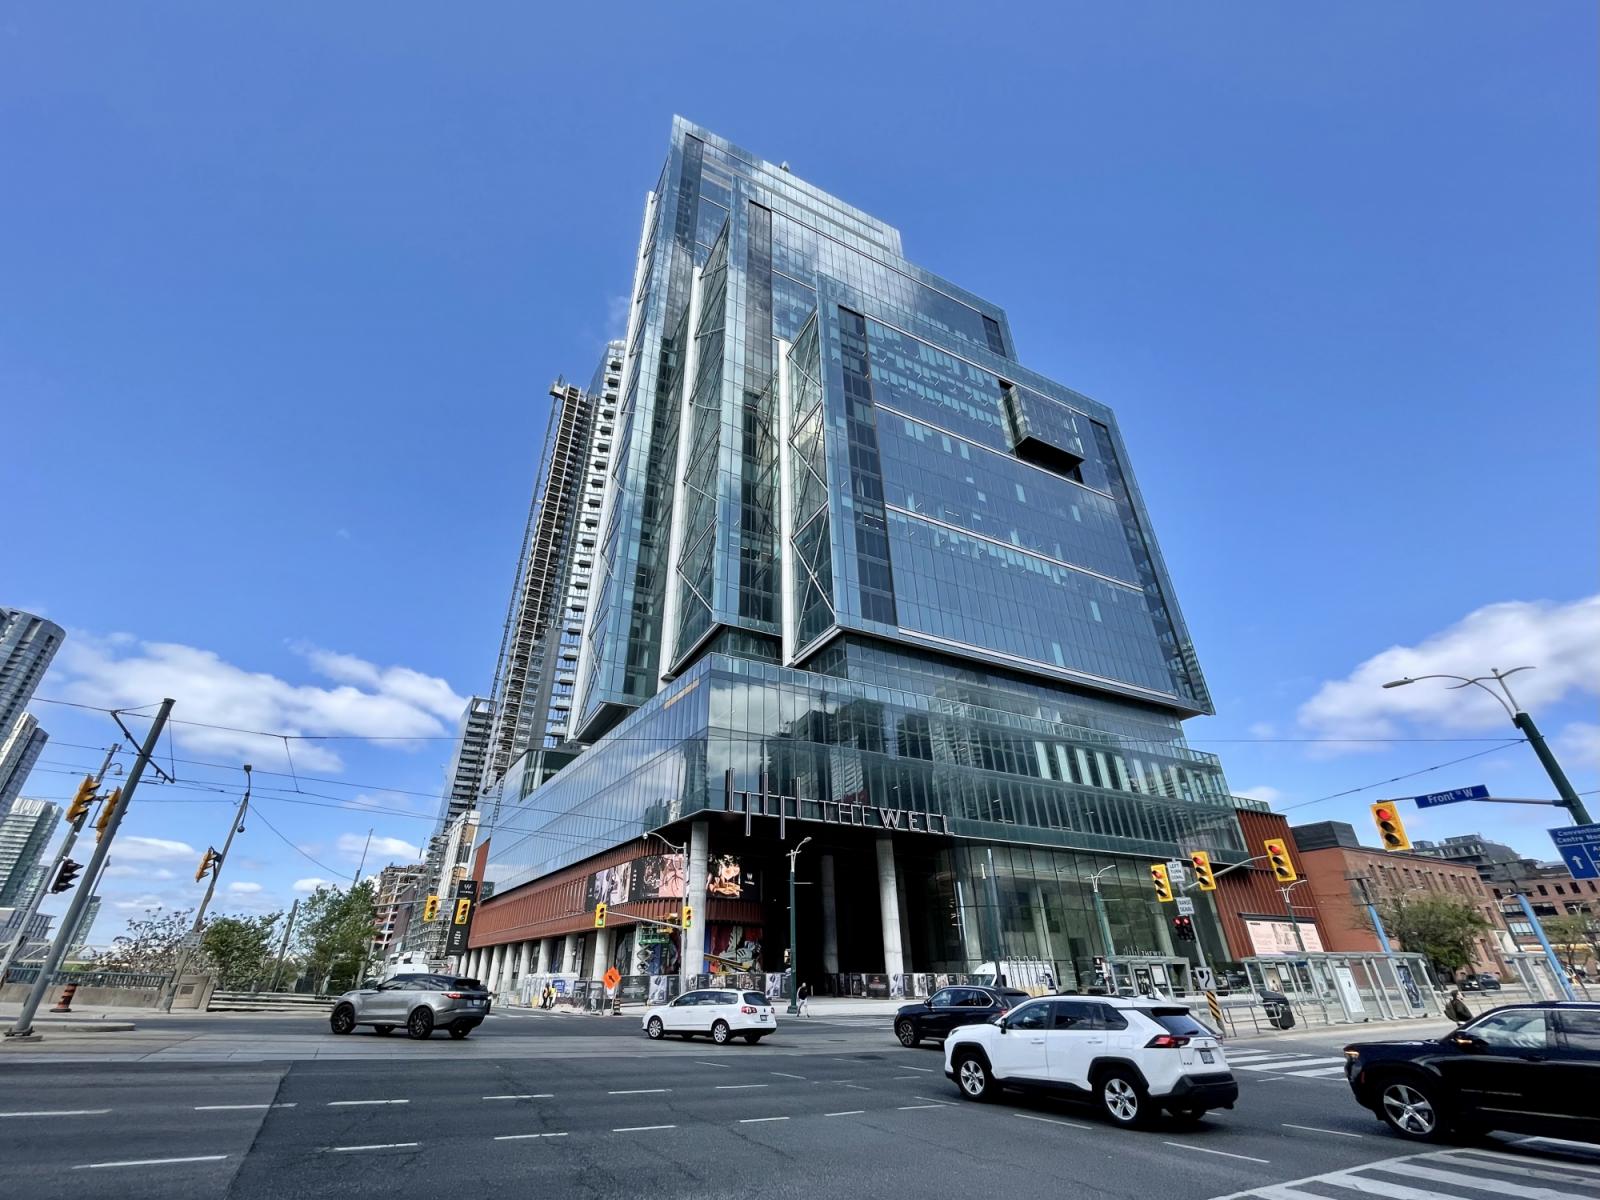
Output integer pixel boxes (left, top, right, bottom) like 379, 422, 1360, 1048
0, 3, 1600, 941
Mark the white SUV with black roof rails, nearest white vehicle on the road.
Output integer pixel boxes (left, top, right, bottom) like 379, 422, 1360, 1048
944, 995, 1238, 1126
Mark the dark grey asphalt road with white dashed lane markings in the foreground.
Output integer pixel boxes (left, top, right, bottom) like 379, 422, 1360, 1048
0, 1014, 1600, 1200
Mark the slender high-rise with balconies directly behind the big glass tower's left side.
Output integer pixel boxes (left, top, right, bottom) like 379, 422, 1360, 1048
483, 342, 622, 800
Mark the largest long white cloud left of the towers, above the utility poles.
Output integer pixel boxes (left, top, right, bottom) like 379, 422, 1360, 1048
53, 630, 466, 771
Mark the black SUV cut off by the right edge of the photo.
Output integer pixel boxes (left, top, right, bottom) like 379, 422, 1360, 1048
1344, 1002, 1600, 1142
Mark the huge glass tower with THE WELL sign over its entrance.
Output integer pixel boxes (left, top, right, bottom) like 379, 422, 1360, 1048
469, 118, 1264, 986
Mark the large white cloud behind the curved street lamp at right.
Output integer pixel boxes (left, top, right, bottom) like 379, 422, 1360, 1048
1299, 595, 1600, 738
